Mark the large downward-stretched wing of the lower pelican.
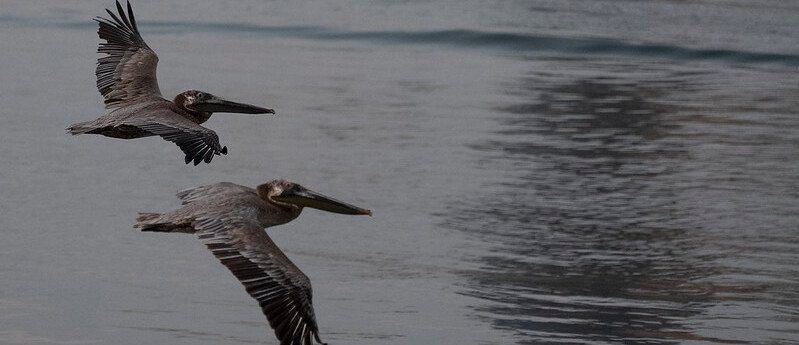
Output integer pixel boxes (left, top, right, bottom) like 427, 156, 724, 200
193, 216, 322, 345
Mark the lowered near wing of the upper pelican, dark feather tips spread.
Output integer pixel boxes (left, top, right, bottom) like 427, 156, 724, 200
125, 110, 227, 165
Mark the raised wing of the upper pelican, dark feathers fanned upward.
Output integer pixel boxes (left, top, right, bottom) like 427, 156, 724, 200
95, 1, 161, 109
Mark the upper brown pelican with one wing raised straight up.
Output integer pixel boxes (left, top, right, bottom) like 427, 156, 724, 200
67, 1, 275, 165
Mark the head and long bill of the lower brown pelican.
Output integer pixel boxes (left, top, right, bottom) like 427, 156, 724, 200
258, 180, 372, 216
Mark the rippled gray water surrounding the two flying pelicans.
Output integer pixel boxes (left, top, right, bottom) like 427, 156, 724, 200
0, 0, 799, 344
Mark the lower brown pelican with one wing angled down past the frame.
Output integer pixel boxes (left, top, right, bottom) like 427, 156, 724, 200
134, 180, 372, 345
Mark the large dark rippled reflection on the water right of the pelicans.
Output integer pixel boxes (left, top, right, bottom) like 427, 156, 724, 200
444, 66, 799, 344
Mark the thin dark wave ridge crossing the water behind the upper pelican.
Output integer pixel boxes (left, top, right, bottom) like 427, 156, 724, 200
10, 17, 799, 66
